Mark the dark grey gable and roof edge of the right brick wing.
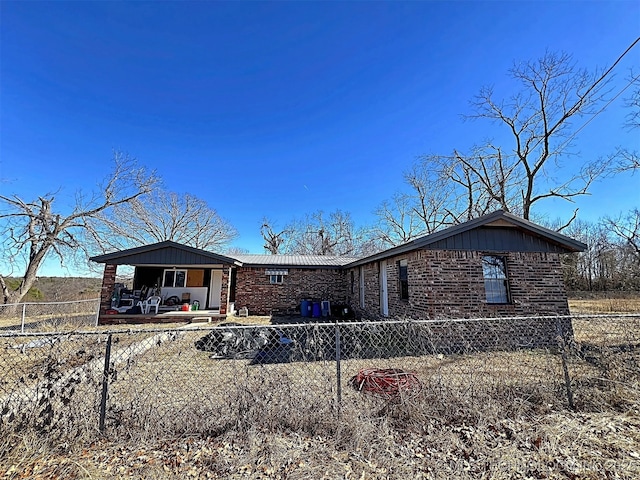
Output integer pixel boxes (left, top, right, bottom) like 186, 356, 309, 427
346, 210, 587, 267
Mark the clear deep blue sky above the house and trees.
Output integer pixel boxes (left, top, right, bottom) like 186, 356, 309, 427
0, 1, 640, 274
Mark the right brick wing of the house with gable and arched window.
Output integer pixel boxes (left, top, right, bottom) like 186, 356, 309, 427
344, 210, 586, 318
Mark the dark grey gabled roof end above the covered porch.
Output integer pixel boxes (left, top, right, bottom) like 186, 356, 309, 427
89, 240, 238, 265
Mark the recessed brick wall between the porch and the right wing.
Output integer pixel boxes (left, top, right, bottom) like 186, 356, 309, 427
235, 267, 347, 315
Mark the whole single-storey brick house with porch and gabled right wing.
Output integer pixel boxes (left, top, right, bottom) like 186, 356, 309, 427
92, 210, 586, 323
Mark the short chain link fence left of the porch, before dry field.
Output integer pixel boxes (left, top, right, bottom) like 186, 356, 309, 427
0, 298, 100, 333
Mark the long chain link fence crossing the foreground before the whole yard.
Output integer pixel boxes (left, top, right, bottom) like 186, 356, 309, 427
0, 315, 640, 438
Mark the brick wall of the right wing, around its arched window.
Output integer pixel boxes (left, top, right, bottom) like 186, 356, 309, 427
349, 250, 569, 319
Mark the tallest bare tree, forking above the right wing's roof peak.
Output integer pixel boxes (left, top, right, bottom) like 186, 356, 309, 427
464, 52, 610, 219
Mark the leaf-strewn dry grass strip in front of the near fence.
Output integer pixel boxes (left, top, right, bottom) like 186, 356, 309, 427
0, 411, 640, 480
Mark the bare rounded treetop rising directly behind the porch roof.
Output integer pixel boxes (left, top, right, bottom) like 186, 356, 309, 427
84, 189, 237, 251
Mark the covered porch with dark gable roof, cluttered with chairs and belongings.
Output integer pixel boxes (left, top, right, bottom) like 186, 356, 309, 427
91, 241, 240, 324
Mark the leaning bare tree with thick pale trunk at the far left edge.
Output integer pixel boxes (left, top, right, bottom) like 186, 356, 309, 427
0, 153, 157, 303
